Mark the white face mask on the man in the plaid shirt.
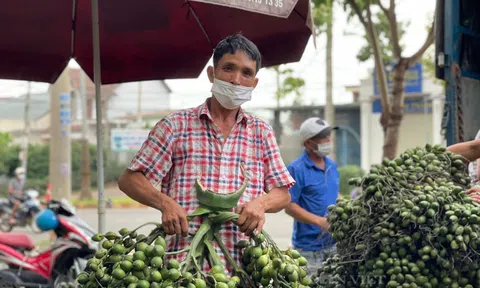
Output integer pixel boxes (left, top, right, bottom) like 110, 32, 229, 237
211, 78, 254, 110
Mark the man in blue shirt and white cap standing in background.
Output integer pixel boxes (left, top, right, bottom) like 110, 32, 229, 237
286, 117, 339, 274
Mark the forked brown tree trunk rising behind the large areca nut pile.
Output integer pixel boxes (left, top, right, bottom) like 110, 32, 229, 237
344, 0, 434, 159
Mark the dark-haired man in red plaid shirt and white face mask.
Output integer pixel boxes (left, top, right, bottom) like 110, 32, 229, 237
118, 35, 294, 268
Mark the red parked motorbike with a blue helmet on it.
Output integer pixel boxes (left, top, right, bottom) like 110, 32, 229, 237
0, 200, 98, 288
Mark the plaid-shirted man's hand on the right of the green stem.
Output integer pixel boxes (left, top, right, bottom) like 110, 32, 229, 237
235, 196, 266, 235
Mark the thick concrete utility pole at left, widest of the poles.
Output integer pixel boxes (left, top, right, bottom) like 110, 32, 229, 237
49, 68, 72, 199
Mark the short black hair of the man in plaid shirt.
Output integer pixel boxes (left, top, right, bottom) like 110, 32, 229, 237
213, 33, 262, 73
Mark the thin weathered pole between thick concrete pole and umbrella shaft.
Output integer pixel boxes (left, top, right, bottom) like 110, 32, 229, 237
79, 69, 92, 200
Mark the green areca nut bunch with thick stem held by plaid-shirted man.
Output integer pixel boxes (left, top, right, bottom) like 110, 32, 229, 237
77, 167, 311, 288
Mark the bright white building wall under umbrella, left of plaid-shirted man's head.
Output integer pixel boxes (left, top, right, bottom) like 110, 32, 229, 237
107, 80, 170, 120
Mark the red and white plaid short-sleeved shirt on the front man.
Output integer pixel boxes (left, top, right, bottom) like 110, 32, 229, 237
129, 100, 295, 270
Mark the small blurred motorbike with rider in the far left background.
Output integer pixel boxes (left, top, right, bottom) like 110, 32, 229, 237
0, 189, 41, 232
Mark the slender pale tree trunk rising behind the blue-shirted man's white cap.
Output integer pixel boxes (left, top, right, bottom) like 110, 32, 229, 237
312, 0, 335, 157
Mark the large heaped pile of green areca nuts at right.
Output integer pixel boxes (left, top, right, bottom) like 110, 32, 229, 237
312, 145, 480, 288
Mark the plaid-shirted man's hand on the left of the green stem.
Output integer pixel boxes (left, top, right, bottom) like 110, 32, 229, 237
160, 197, 188, 237
